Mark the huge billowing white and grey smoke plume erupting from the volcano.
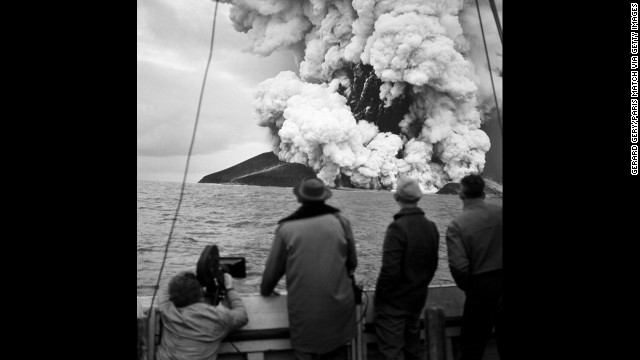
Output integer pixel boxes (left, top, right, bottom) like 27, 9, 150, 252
225, 0, 502, 192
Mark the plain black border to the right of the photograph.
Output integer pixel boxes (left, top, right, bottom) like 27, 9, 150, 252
503, 2, 638, 359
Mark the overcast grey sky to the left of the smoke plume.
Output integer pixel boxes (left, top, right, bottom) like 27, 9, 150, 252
137, 0, 296, 183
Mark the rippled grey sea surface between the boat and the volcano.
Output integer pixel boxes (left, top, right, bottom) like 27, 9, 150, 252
137, 180, 502, 296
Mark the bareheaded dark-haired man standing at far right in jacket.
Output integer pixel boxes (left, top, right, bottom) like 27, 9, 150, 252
446, 174, 502, 360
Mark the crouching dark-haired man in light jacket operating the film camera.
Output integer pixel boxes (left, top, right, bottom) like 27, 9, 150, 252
156, 271, 249, 360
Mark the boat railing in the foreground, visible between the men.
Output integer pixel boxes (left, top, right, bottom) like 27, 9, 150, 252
138, 285, 465, 360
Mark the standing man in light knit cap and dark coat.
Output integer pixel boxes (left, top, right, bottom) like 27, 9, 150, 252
374, 176, 440, 360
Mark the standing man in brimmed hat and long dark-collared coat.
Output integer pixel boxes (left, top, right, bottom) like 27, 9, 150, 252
260, 177, 357, 360
